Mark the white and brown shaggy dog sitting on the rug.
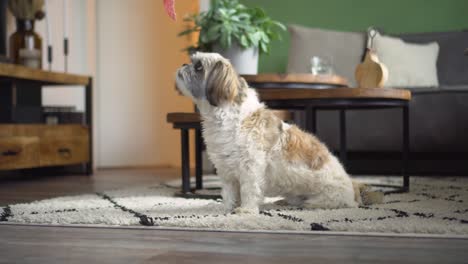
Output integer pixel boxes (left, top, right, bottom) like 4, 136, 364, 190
176, 52, 380, 213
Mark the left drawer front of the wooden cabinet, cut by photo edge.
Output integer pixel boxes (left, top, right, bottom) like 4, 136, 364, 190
0, 137, 39, 170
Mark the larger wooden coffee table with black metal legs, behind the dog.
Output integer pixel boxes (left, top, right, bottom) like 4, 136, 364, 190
246, 74, 411, 192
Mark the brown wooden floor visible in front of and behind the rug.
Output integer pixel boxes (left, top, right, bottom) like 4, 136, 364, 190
0, 169, 468, 264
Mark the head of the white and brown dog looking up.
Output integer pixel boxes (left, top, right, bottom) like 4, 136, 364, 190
176, 52, 246, 107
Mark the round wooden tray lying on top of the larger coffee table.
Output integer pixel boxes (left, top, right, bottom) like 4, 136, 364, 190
241, 73, 348, 86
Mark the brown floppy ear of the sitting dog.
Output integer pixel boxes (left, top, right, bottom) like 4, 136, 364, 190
206, 61, 239, 106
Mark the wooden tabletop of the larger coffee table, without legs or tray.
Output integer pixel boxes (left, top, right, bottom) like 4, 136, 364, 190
257, 88, 411, 101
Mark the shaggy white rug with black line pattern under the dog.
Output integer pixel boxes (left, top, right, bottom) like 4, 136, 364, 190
0, 177, 468, 235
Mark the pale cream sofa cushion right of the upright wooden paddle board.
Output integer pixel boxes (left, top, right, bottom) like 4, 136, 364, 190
373, 33, 439, 87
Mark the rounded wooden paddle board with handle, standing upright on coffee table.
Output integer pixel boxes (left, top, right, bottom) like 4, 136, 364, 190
355, 28, 388, 88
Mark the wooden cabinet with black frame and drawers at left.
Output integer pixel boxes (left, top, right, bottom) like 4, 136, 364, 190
0, 63, 93, 174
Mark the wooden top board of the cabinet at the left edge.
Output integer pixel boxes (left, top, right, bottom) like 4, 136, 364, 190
0, 63, 91, 86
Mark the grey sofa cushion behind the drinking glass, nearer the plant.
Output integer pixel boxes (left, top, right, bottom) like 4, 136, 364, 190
287, 25, 366, 86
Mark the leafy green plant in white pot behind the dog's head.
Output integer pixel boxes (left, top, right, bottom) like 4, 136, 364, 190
179, 0, 286, 74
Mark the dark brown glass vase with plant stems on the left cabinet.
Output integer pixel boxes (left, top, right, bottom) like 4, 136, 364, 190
8, 0, 44, 69
